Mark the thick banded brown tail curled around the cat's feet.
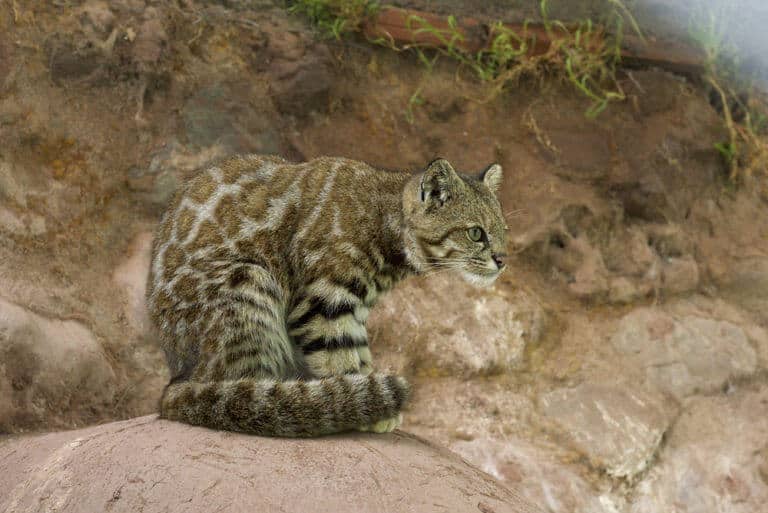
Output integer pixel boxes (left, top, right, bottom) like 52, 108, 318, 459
160, 374, 410, 437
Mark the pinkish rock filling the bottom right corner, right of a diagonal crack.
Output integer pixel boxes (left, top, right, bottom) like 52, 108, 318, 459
629, 388, 768, 513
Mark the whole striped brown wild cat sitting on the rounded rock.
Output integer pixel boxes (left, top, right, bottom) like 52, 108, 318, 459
147, 155, 505, 436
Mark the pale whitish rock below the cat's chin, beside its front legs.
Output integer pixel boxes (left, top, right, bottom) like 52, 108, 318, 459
369, 274, 544, 377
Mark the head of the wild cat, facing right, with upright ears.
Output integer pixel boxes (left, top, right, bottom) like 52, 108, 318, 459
403, 159, 507, 286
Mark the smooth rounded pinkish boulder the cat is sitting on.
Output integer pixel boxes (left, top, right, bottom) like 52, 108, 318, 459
0, 417, 541, 513
